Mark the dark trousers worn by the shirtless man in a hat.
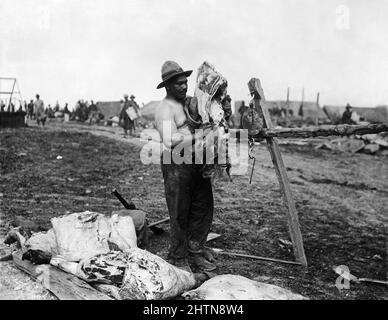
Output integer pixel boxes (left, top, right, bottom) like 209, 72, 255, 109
162, 163, 214, 259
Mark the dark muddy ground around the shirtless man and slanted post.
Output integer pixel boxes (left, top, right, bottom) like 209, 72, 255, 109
0, 124, 388, 299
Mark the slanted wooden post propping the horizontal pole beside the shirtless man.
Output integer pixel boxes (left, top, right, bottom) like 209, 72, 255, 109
248, 78, 307, 267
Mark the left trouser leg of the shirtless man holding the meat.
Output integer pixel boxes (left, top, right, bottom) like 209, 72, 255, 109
162, 164, 193, 260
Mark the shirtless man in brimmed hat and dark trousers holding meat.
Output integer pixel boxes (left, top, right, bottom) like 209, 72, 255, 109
155, 61, 216, 272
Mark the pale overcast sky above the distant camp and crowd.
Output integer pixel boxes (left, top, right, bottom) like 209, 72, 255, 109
0, 0, 388, 106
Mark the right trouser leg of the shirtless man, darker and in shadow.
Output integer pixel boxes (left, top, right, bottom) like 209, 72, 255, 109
188, 170, 214, 252
